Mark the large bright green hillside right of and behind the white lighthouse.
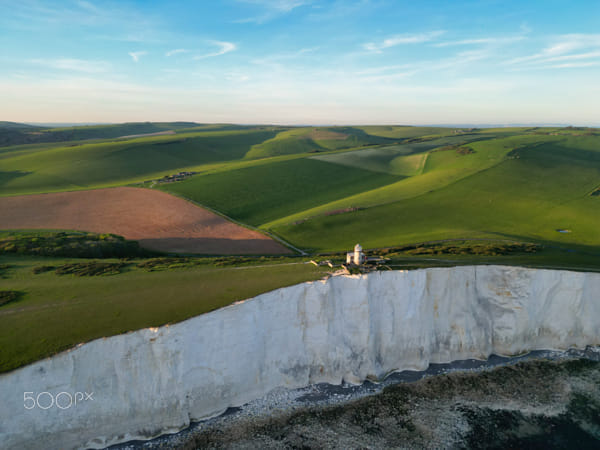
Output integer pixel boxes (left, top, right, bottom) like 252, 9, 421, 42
272, 136, 600, 251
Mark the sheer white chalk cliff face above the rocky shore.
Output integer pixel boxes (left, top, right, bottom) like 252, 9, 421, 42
0, 266, 600, 448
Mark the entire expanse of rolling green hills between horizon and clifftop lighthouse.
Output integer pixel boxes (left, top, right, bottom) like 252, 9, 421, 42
0, 123, 600, 255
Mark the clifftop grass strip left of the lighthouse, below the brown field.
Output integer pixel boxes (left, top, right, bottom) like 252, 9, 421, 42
0, 255, 329, 372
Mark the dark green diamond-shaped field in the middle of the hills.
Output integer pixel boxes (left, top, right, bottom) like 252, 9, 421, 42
161, 158, 399, 226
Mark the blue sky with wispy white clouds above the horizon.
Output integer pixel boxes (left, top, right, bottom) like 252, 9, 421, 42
0, 0, 600, 126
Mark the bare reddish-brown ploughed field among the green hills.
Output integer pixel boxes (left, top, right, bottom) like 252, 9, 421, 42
0, 187, 290, 255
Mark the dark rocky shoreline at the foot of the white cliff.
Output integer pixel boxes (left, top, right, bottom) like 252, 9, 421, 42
109, 347, 600, 450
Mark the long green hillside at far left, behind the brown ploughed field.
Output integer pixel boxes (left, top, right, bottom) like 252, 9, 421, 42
0, 129, 276, 195
